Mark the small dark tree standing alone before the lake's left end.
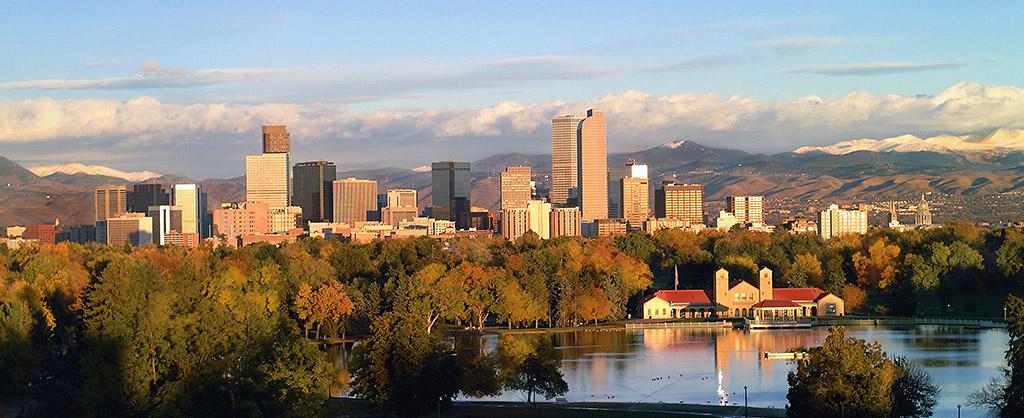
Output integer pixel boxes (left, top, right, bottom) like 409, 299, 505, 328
506, 339, 568, 406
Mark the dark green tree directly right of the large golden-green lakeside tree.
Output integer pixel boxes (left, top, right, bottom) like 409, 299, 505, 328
890, 357, 939, 418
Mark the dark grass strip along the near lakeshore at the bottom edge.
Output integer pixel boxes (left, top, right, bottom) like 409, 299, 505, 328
326, 399, 785, 418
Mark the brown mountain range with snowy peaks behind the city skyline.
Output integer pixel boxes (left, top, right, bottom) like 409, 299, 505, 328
0, 129, 1024, 228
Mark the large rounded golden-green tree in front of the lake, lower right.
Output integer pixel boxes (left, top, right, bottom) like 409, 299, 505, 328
786, 327, 898, 418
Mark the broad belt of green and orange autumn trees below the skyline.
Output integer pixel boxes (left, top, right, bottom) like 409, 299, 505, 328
6, 223, 1024, 415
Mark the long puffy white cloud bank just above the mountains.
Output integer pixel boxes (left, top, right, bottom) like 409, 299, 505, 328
0, 83, 1024, 168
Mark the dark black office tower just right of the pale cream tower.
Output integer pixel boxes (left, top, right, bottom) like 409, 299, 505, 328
292, 161, 337, 222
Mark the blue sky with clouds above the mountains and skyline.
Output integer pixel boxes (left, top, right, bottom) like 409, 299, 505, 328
0, 1, 1024, 178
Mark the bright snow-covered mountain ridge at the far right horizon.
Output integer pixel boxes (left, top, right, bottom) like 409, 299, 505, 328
794, 129, 1024, 155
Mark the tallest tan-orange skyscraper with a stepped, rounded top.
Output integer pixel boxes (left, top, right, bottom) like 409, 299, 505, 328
577, 109, 608, 221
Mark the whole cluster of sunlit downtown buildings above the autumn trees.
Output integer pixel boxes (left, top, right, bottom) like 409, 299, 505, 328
7, 110, 931, 246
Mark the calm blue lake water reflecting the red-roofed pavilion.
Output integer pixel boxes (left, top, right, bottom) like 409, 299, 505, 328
331, 325, 1009, 417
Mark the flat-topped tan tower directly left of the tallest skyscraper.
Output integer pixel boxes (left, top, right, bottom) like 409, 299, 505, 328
550, 115, 582, 206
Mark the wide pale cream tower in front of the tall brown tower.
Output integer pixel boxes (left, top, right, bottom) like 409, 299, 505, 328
246, 153, 291, 208
